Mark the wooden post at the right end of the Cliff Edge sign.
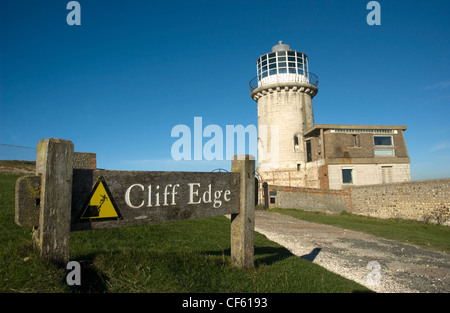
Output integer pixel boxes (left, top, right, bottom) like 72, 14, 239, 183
231, 155, 255, 269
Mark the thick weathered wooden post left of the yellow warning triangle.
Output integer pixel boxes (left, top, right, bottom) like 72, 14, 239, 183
34, 138, 74, 264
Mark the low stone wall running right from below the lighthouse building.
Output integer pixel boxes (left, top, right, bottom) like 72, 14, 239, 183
269, 178, 450, 226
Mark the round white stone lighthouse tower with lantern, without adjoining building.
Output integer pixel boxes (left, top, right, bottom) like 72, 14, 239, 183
250, 41, 318, 187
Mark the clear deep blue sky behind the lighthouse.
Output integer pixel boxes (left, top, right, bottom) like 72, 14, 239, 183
0, 0, 450, 180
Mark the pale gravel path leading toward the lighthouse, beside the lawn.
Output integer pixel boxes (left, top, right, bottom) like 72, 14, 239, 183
255, 211, 450, 293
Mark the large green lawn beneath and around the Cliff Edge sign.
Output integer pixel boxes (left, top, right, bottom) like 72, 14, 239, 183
0, 173, 368, 293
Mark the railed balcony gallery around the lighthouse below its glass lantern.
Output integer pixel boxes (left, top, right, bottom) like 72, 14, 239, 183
249, 72, 319, 91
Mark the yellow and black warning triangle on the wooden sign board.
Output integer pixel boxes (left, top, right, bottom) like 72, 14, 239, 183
80, 176, 122, 221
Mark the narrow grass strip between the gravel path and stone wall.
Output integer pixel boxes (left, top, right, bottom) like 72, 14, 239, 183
271, 209, 450, 252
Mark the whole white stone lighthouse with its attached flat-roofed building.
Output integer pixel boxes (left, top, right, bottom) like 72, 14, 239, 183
250, 41, 411, 191
